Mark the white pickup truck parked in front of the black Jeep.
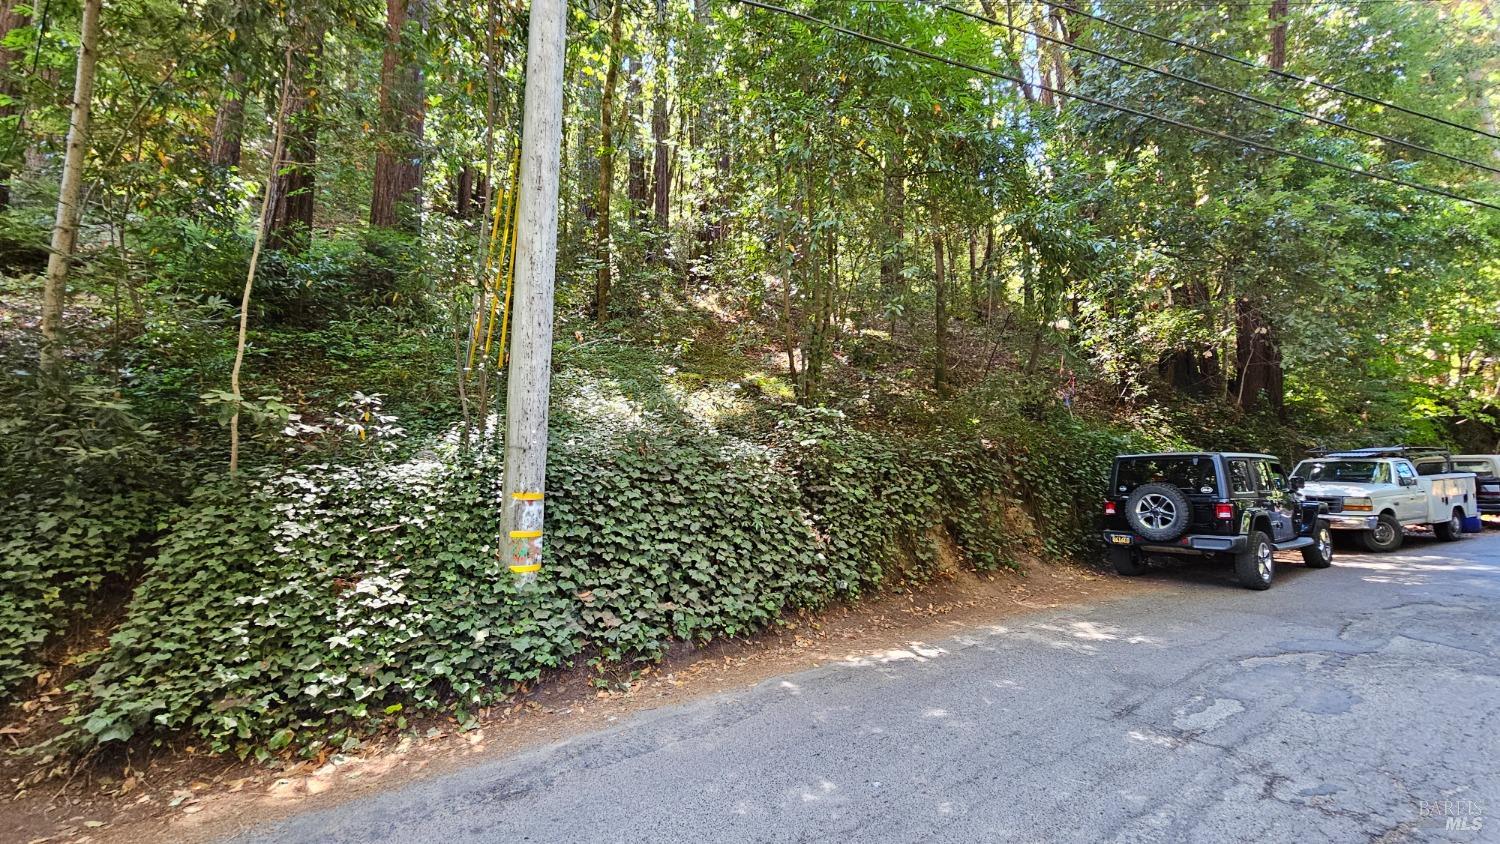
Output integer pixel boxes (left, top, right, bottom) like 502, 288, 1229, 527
1292, 447, 1479, 552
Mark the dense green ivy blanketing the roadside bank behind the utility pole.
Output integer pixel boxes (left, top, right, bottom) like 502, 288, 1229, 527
74, 387, 1134, 756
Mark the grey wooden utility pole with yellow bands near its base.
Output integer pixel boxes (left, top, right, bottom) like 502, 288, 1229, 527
501, 0, 567, 585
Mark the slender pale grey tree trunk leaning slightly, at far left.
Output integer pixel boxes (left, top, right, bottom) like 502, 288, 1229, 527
41, 0, 104, 381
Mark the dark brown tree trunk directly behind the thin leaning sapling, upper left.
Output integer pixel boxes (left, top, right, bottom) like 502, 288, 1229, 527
266, 18, 324, 252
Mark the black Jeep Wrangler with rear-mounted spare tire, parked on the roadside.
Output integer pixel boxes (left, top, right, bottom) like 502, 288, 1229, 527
1104, 451, 1334, 589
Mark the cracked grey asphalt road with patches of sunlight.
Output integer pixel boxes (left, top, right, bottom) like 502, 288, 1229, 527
240, 529, 1500, 844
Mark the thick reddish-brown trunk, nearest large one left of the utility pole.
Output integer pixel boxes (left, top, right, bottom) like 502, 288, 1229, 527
371, 0, 428, 232
